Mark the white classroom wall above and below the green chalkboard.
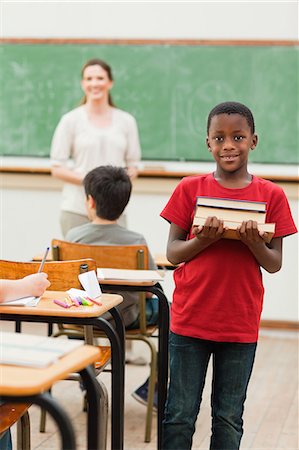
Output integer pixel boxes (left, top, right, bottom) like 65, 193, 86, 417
0, 0, 298, 320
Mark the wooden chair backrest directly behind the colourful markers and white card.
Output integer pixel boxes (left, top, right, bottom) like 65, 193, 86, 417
0, 258, 97, 291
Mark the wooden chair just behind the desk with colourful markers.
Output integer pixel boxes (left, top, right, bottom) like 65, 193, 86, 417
0, 258, 111, 448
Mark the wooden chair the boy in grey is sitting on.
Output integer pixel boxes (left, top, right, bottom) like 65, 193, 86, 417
52, 239, 158, 442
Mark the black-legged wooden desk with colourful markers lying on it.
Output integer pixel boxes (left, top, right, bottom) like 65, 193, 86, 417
0, 291, 125, 450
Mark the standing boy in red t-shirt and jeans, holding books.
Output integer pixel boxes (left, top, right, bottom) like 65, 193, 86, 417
161, 102, 297, 450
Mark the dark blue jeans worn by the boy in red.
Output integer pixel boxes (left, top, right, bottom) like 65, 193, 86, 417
162, 332, 256, 450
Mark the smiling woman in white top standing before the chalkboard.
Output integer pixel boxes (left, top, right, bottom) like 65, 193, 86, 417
51, 59, 141, 236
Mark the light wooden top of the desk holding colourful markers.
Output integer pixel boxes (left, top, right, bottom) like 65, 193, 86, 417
0, 291, 123, 318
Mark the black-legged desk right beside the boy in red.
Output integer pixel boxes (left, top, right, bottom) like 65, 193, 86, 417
99, 280, 169, 450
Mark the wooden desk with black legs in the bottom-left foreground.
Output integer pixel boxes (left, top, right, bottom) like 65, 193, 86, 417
0, 342, 100, 450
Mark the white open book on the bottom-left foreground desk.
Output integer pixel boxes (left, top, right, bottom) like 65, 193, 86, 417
0, 331, 84, 368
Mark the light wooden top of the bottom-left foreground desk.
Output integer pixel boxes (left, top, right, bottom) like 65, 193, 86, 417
0, 342, 100, 397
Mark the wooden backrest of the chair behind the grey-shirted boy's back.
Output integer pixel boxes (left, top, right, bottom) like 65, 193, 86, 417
52, 239, 149, 270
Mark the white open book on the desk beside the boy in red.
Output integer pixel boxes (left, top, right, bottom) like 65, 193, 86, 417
97, 268, 163, 282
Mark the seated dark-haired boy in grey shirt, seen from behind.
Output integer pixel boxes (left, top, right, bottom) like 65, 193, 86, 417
66, 166, 159, 403
